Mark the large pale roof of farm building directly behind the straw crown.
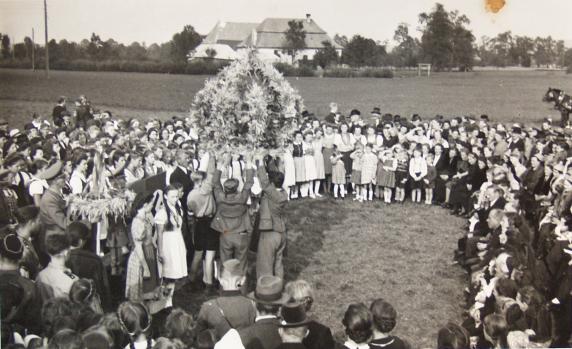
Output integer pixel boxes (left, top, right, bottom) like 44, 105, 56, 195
237, 18, 342, 49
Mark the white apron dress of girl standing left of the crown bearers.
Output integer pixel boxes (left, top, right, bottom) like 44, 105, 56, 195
155, 204, 187, 279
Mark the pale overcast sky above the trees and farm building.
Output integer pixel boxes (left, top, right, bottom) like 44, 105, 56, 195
0, 0, 572, 46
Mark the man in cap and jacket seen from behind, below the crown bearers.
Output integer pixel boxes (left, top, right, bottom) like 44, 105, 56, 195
196, 259, 256, 340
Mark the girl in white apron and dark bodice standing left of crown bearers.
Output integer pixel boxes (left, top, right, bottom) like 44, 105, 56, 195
155, 185, 187, 297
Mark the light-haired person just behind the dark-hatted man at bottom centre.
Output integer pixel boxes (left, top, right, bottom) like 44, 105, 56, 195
284, 280, 335, 349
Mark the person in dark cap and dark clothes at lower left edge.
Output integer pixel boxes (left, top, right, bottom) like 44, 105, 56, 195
0, 230, 42, 334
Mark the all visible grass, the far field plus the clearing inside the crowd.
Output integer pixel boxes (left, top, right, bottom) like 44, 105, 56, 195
0, 69, 572, 348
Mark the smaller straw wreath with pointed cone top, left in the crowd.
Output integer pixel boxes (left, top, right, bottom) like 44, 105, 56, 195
66, 151, 133, 223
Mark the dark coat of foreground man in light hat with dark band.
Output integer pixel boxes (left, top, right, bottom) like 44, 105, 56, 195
238, 318, 282, 349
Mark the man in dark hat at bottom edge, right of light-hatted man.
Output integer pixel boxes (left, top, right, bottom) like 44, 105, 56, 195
276, 301, 310, 349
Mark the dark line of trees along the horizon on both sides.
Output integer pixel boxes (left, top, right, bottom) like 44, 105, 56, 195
0, 3, 572, 73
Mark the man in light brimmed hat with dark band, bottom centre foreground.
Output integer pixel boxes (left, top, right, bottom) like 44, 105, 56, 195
215, 275, 290, 349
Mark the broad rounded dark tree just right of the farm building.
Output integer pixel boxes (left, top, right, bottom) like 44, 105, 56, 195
342, 35, 387, 67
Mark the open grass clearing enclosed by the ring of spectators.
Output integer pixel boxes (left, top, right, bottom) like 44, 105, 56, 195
175, 199, 466, 348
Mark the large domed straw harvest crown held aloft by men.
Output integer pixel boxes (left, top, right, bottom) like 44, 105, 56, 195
191, 50, 303, 153
